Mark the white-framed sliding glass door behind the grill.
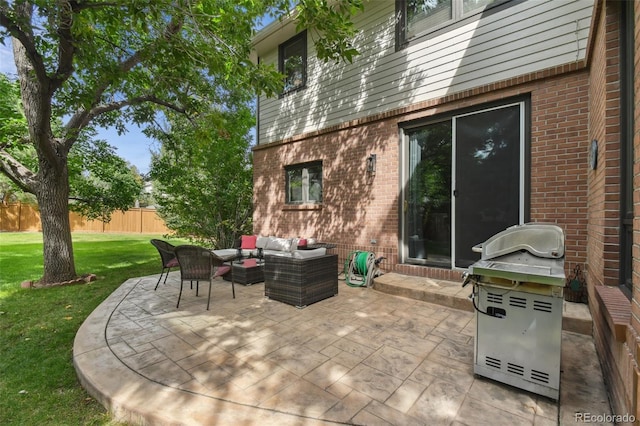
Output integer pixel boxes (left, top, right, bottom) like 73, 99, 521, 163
402, 103, 525, 268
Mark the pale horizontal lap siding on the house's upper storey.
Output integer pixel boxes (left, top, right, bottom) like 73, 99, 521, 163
258, 0, 593, 144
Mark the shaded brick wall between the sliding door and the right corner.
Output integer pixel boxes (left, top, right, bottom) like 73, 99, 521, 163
530, 72, 589, 271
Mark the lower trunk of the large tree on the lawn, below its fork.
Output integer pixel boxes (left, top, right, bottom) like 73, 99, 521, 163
36, 161, 76, 284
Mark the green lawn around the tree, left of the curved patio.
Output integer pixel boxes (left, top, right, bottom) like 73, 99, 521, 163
0, 233, 185, 425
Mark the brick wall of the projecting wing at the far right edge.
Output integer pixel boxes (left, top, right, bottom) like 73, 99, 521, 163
587, 1, 640, 419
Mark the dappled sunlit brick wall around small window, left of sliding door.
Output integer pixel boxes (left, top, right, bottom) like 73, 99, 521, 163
254, 117, 399, 260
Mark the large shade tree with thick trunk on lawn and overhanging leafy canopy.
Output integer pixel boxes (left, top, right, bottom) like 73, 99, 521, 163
0, 0, 362, 282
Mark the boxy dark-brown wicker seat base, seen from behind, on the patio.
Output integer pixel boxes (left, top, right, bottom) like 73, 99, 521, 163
264, 254, 338, 308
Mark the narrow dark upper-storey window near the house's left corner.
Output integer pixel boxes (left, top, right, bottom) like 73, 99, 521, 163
278, 31, 307, 94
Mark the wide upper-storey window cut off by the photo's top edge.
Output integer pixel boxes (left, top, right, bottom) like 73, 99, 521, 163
396, 0, 510, 47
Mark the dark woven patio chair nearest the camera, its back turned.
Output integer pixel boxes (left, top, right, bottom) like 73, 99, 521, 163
175, 245, 236, 310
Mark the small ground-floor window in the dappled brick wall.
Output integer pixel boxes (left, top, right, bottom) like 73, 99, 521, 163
285, 162, 322, 204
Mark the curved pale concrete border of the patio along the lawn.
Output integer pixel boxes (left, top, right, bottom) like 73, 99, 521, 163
73, 278, 332, 426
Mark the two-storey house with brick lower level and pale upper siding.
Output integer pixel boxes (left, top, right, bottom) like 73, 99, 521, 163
253, 0, 640, 418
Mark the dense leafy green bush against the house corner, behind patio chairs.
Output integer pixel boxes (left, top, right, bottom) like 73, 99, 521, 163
151, 100, 255, 248
